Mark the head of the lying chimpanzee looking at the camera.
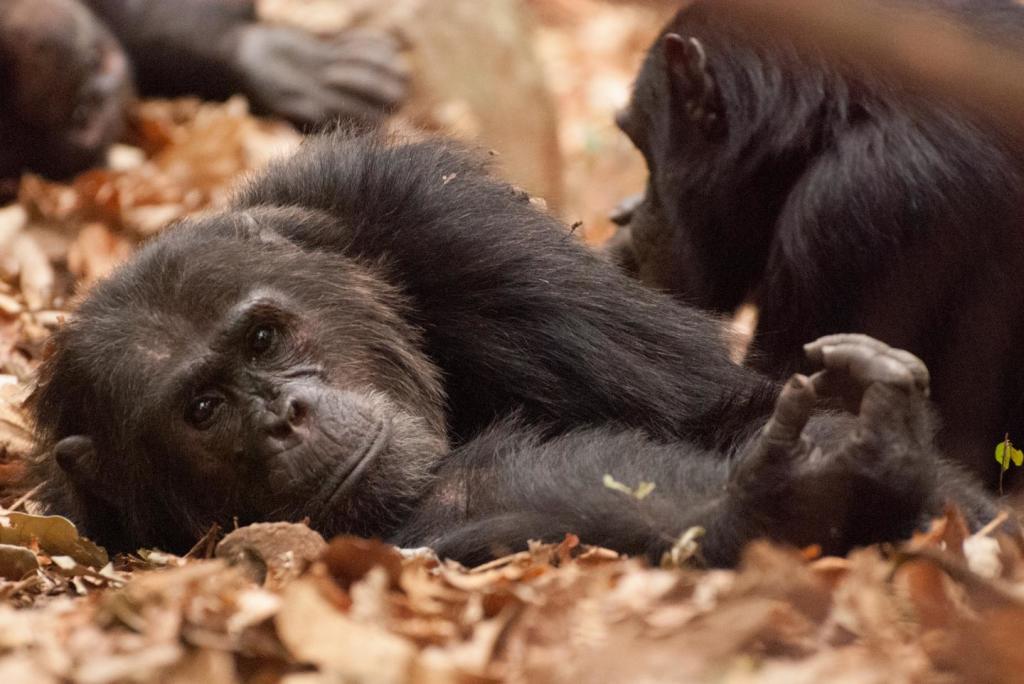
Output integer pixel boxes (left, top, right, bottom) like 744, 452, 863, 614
32, 208, 446, 550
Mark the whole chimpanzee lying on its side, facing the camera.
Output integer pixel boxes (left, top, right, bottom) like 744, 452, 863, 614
32, 137, 992, 564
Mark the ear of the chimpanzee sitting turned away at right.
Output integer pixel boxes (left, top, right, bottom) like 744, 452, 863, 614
664, 33, 725, 138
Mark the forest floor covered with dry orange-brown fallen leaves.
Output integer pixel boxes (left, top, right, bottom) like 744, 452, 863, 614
0, 0, 1024, 684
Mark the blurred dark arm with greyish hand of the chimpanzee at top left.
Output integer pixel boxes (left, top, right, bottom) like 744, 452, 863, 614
86, 0, 406, 125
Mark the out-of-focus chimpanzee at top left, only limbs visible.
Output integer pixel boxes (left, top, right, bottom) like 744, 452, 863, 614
0, 0, 406, 177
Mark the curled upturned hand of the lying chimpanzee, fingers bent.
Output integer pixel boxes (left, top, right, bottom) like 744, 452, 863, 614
730, 335, 942, 552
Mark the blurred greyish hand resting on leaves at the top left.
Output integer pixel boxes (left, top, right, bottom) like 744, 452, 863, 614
237, 24, 408, 126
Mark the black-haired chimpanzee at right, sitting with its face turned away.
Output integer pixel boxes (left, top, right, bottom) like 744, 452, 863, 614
612, 0, 1024, 480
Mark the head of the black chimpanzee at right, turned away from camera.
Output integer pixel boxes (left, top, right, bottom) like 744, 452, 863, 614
612, 1, 844, 312
